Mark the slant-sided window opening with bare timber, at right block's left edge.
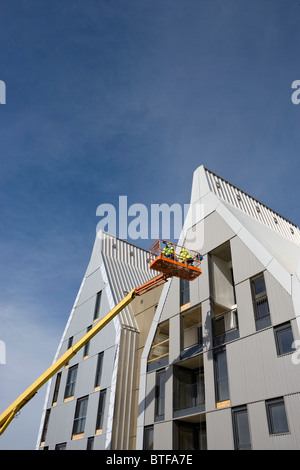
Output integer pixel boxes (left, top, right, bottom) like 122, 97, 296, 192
148, 320, 169, 370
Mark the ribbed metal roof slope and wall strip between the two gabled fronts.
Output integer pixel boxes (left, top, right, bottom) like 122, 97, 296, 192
102, 233, 155, 449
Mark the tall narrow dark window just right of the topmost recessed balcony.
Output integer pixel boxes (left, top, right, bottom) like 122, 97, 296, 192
251, 274, 271, 330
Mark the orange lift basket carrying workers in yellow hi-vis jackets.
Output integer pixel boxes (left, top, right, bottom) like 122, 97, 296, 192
149, 239, 201, 281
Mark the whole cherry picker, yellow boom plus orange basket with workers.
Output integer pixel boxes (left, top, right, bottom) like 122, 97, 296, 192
0, 239, 202, 434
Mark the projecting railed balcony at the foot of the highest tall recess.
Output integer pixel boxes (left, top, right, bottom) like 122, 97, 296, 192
212, 308, 239, 347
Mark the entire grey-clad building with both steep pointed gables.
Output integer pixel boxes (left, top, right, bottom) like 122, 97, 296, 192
37, 166, 300, 450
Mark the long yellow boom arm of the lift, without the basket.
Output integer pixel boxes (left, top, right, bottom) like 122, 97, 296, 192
0, 274, 170, 434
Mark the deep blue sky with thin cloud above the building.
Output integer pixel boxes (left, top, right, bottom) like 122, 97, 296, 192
0, 0, 300, 449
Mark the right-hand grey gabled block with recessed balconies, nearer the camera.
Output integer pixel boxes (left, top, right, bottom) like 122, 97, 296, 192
137, 167, 300, 450
